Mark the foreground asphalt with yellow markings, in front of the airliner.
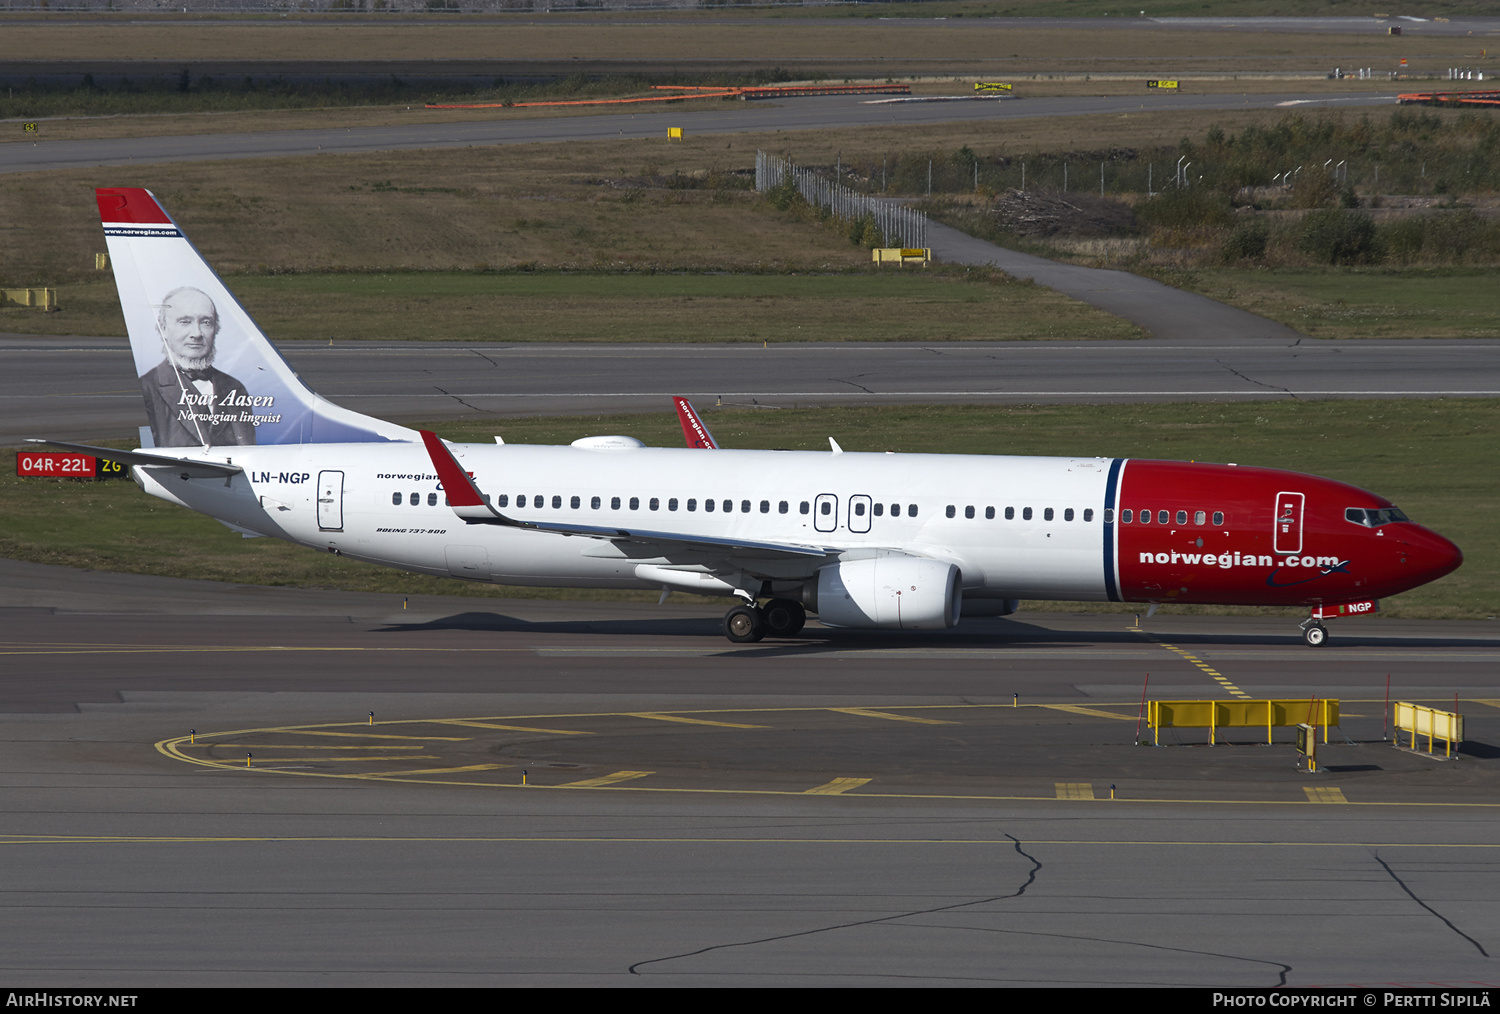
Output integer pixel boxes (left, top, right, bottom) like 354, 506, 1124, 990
0, 561, 1500, 987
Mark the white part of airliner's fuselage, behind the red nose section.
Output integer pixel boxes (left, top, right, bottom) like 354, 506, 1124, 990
135, 443, 1110, 600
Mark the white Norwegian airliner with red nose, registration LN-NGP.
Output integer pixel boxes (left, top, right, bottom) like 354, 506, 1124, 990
48, 189, 1463, 644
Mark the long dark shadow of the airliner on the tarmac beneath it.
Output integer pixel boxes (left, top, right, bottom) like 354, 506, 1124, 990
375, 611, 1500, 656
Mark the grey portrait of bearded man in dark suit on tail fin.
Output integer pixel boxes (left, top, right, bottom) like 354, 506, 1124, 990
141, 287, 255, 447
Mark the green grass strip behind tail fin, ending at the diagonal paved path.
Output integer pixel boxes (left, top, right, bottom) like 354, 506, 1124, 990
0, 267, 1143, 342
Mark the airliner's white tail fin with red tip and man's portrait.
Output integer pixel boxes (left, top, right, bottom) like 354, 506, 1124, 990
95, 188, 417, 447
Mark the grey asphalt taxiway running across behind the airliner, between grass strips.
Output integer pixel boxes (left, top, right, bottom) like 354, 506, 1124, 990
0, 336, 1500, 444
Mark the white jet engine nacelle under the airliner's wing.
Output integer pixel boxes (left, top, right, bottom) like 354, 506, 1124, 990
809, 557, 963, 630
